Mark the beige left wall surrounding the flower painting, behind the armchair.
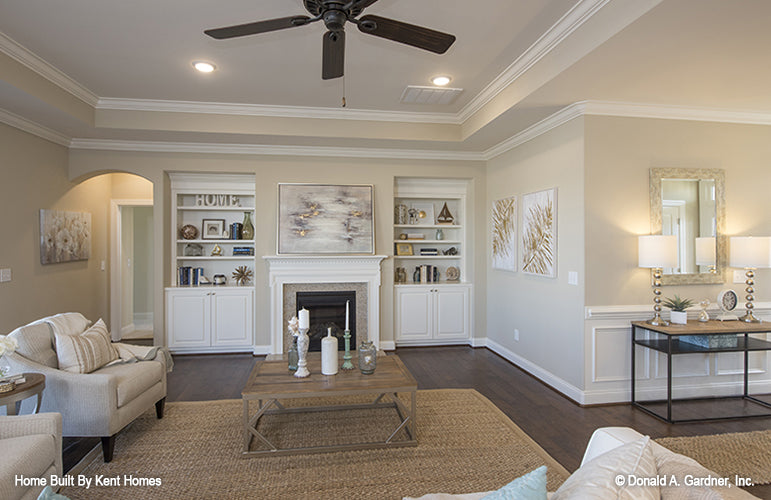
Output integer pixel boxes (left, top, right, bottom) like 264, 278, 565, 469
0, 124, 110, 333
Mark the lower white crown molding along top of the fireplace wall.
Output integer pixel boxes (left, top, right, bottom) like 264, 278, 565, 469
69, 139, 484, 161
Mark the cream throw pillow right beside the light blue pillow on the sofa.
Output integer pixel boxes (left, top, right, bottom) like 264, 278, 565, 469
551, 436, 659, 500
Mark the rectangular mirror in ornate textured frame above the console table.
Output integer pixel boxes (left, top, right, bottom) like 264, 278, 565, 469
649, 168, 728, 285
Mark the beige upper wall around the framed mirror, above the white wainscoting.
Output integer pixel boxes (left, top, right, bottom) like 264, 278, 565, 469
585, 116, 771, 306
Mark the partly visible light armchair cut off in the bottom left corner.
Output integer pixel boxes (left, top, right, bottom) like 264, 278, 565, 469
0, 413, 62, 500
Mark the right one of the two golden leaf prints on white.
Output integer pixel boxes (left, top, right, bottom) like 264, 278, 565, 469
521, 188, 557, 278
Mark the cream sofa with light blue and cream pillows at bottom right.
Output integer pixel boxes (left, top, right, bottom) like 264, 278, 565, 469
404, 427, 757, 500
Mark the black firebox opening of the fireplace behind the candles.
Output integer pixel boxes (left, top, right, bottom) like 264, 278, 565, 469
296, 290, 356, 352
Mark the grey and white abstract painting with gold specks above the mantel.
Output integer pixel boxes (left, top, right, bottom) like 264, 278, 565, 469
277, 183, 375, 255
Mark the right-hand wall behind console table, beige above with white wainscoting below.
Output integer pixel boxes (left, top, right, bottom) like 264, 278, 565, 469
584, 116, 771, 403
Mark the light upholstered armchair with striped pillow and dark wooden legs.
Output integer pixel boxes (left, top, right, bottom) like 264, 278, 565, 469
6, 313, 171, 462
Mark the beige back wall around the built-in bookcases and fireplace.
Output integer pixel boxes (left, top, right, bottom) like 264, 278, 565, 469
70, 150, 486, 345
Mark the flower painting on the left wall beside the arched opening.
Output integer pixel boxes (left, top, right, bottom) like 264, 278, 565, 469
40, 209, 91, 264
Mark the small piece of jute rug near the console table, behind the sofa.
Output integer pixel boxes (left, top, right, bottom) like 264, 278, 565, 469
656, 430, 771, 484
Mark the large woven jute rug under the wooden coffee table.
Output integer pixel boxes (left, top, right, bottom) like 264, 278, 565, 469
62, 389, 568, 500
